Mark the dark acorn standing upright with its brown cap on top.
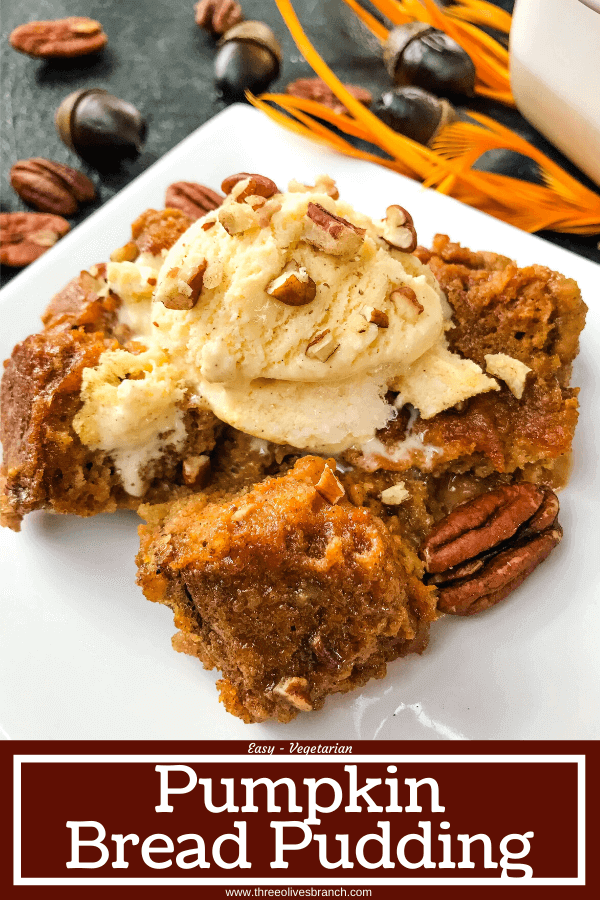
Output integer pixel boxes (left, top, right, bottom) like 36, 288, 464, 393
215, 21, 282, 100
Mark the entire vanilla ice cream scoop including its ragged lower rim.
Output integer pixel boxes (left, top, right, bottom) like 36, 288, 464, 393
152, 182, 497, 453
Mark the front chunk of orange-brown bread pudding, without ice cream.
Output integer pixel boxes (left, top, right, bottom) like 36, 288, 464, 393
137, 456, 435, 722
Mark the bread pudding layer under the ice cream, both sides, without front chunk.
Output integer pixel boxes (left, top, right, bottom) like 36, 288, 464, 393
0, 210, 585, 546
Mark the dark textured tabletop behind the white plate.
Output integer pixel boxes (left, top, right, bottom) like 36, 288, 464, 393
0, 0, 600, 284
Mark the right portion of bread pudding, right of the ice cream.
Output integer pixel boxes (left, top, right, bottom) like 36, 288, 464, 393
347, 235, 587, 487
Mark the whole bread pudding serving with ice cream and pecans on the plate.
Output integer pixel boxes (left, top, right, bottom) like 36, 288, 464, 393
1, 173, 585, 721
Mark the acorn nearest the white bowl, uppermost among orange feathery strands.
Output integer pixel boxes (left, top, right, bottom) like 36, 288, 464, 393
383, 22, 475, 97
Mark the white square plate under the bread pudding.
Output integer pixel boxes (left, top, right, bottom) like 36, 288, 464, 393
0, 106, 600, 740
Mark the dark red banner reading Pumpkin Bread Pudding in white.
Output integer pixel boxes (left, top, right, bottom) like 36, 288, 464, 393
1, 741, 597, 896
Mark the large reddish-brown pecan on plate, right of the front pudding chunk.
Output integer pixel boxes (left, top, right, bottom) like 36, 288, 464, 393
421, 482, 562, 616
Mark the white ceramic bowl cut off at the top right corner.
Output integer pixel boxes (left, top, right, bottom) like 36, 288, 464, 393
510, 0, 600, 185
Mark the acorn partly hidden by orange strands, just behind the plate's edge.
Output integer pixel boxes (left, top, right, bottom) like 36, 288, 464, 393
371, 86, 463, 146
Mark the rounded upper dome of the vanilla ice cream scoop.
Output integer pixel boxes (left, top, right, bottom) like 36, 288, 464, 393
153, 193, 444, 384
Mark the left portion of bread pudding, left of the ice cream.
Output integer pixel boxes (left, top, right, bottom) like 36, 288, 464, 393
0, 210, 220, 530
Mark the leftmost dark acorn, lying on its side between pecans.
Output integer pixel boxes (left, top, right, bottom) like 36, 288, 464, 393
55, 88, 147, 163
